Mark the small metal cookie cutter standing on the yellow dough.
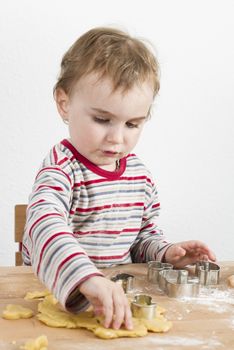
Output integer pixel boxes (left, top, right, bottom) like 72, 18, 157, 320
131, 294, 157, 320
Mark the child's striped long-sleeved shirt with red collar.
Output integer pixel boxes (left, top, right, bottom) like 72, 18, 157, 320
22, 140, 170, 312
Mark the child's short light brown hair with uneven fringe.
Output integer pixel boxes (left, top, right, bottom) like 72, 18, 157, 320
54, 27, 160, 96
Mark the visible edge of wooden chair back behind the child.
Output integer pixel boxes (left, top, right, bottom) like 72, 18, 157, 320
15, 204, 27, 266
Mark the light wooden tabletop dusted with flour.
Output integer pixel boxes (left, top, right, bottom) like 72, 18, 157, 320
0, 262, 234, 350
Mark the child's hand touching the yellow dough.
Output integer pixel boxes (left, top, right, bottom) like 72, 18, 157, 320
79, 276, 133, 329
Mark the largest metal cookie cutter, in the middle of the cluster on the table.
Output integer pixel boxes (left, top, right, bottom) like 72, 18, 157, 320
159, 270, 200, 298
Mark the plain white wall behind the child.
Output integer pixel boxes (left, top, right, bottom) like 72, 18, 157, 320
0, 0, 234, 265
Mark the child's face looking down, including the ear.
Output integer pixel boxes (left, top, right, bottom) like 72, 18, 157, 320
57, 74, 153, 171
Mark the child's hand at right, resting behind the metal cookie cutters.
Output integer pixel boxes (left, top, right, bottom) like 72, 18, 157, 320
164, 241, 216, 268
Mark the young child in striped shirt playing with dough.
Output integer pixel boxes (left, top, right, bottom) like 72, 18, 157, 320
23, 28, 215, 329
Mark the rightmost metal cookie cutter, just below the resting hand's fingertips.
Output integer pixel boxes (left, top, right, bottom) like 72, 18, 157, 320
195, 261, 220, 286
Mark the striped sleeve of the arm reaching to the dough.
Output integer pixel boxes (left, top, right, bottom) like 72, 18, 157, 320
23, 159, 102, 312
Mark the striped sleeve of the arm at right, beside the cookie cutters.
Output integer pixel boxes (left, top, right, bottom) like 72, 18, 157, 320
131, 179, 172, 263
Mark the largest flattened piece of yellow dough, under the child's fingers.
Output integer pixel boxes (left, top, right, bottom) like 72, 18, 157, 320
37, 295, 172, 339
